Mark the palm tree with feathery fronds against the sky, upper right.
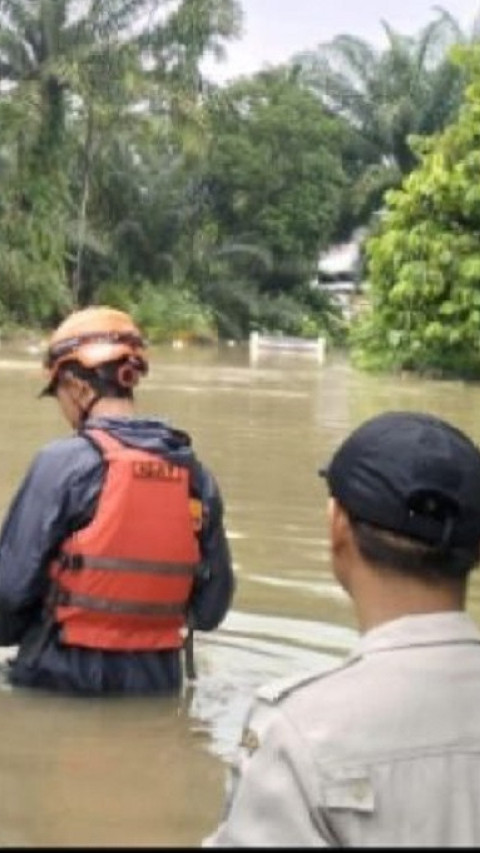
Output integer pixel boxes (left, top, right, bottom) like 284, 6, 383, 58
293, 6, 479, 220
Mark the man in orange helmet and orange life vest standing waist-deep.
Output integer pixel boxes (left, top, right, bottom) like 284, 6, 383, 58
0, 306, 234, 694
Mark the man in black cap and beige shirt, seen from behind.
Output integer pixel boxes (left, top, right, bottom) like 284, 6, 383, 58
203, 412, 480, 847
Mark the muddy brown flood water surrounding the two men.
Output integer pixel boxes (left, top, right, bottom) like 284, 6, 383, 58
0, 346, 480, 846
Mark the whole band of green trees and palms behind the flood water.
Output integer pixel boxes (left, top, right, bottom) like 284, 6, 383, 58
0, 0, 480, 370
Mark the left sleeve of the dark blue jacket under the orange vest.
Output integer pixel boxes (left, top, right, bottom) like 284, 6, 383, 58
0, 438, 102, 645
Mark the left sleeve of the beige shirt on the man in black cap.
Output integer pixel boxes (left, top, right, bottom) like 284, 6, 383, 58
202, 708, 330, 847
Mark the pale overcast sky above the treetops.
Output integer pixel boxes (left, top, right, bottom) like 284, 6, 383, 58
204, 0, 480, 82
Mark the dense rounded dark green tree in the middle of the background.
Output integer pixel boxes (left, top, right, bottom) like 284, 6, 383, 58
205, 68, 343, 293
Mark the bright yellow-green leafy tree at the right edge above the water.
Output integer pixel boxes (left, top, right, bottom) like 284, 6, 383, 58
353, 46, 480, 377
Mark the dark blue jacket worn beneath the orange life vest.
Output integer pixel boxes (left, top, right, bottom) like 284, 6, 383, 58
0, 418, 234, 693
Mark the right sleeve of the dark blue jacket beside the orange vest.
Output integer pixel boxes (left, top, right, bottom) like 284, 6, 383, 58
190, 463, 235, 631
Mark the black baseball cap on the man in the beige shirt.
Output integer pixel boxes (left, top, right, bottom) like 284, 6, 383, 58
319, 412, 480, 548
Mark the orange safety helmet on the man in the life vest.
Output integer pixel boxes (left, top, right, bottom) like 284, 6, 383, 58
40, 305, 148, 396
